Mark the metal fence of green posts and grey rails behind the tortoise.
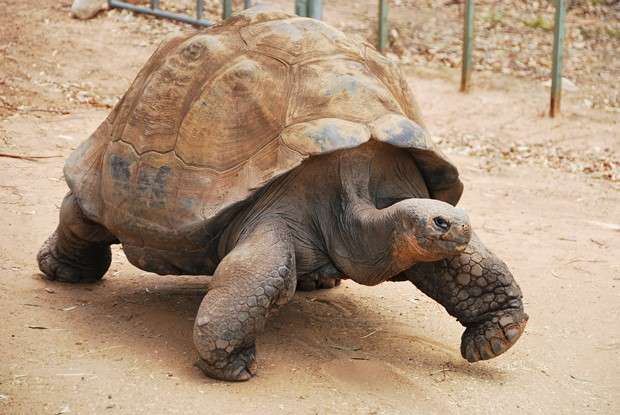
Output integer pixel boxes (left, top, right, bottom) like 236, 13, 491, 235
108, 0, 566, 117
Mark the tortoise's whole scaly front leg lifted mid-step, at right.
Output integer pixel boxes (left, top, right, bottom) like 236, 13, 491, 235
395, 235, 528, 362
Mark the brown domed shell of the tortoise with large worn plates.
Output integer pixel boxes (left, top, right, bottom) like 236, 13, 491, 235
65, 7, 462, 250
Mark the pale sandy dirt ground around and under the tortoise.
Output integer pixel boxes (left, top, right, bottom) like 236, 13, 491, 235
0, 0, 620, 415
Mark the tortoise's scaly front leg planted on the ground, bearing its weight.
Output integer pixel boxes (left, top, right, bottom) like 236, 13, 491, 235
194, 221, 296, 381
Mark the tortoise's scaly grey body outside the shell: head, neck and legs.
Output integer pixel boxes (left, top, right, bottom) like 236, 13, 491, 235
39, 142, 527, 381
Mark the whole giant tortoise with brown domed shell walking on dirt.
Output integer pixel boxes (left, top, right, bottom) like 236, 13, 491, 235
38, 7, 528, 381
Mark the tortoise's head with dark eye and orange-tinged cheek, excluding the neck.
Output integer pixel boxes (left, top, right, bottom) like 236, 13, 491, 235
386, 199, 471, 267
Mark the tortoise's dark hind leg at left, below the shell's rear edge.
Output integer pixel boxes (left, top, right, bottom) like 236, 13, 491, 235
37, 193, 117, 282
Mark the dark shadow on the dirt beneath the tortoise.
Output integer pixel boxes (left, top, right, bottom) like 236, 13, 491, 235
49, 275, 507, 382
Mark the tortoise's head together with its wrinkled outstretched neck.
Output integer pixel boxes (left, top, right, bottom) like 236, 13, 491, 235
315, 142, 471, 285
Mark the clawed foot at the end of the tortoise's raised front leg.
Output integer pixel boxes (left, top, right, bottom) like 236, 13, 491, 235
461, 308, 529, 363
